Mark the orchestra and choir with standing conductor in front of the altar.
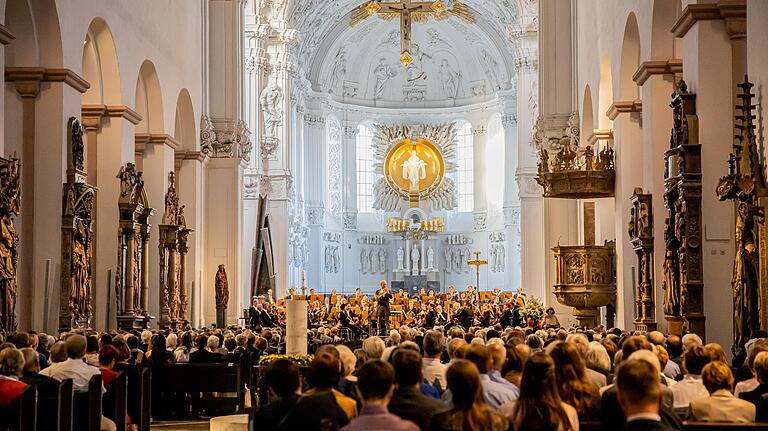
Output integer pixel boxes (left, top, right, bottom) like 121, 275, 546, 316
244, 286, 526, 339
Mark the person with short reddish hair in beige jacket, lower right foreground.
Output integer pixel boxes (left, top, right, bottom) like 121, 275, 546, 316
688, 361, 756, 423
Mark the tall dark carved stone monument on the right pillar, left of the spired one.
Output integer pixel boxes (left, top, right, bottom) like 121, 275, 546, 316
661, 80, 706, 338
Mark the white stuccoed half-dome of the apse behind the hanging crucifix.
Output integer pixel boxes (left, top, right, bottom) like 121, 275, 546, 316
289, 0, 530, 107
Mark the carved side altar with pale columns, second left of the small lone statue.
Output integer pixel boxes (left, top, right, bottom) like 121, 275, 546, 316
115, 163, 155, 330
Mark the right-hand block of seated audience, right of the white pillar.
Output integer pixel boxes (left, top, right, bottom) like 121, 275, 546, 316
255, 326, 768, 431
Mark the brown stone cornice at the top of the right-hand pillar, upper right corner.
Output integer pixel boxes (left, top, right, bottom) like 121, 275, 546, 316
672, 0, 747, 37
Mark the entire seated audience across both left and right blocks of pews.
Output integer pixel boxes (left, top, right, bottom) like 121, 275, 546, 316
0, 318, 768, 431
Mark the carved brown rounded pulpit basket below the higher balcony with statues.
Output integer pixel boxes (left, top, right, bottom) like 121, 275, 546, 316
552, 244, 616, 328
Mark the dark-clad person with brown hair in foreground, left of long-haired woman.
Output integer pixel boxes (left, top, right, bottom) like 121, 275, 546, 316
429, 359, 509, 431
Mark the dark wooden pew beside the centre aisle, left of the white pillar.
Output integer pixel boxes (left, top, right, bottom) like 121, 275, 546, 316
152, 356, 248, 418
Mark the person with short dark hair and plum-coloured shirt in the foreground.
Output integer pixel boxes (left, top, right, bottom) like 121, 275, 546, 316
342, 360, 419, 431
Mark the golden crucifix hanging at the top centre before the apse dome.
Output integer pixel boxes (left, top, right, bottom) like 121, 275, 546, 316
352, 0, 474, 67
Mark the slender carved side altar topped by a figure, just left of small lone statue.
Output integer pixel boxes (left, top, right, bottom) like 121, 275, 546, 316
158, 172, 192, 328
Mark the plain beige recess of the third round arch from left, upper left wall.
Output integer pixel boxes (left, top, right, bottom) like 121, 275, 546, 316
136, 60, 165, 134
